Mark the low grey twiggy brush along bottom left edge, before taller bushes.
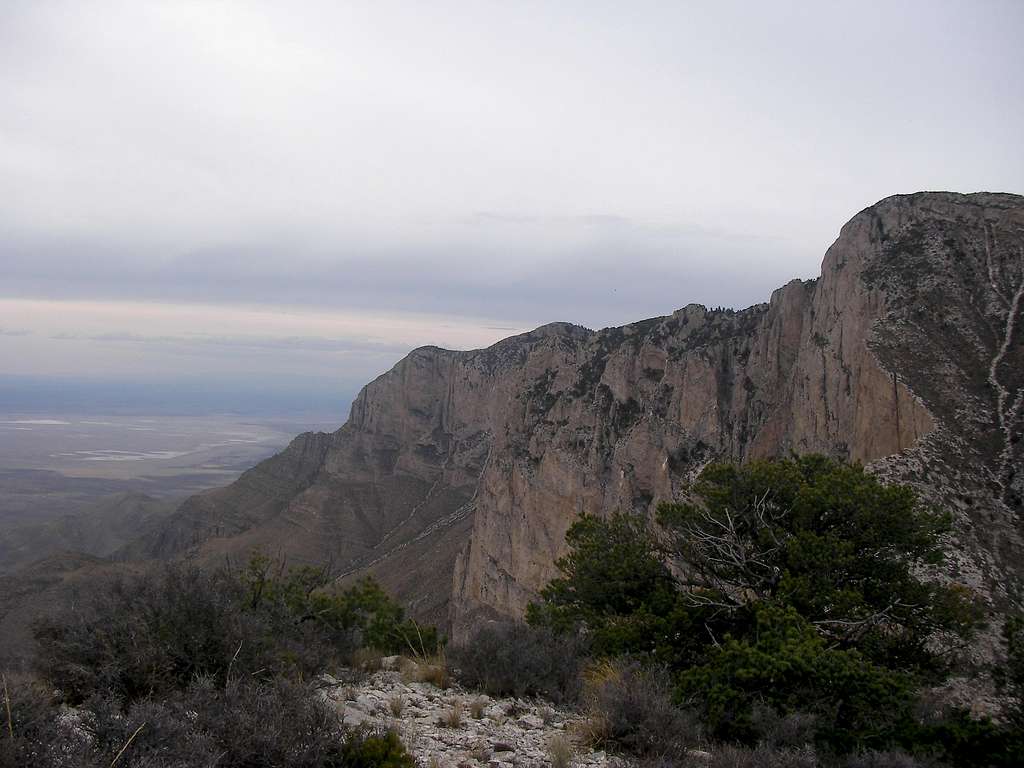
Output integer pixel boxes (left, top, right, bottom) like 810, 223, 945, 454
0, 679, 414, 768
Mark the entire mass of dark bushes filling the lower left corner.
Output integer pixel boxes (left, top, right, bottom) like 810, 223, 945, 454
17, 557, 436, 768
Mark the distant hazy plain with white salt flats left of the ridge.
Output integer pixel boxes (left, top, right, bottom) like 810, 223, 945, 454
0, 411, 342, 527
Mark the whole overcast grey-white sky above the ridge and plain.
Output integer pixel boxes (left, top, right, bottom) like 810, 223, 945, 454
0, 0, 1024, 416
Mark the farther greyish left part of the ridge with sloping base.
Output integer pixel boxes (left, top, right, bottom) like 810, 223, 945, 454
129, 326, 589, 624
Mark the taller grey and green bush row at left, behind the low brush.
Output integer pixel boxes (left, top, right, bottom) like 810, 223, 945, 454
34, 557, 437, 703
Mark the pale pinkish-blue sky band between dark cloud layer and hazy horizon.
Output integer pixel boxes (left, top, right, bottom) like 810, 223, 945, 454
0, 298, 526, 397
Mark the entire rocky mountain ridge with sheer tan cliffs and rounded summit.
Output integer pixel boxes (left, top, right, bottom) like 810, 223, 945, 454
140, 193, 1024, 634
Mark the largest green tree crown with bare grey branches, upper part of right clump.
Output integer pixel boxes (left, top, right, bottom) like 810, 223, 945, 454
658, 456, 981, 679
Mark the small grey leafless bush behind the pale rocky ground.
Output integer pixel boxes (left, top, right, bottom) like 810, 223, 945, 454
447, 622, 585, 702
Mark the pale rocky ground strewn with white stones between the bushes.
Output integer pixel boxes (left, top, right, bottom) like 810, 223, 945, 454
323, 658, 625, 768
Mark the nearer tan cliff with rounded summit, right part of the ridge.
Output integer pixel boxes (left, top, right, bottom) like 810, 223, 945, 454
454, 194, 1024, 628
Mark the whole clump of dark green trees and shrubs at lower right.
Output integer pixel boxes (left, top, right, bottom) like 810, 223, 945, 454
527, 456, 1024, 766
